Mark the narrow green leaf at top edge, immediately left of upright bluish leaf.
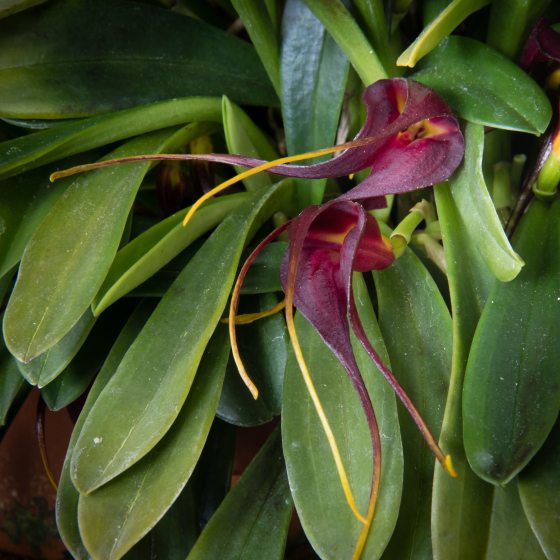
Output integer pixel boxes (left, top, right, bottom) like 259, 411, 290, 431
231, 0, 280, 95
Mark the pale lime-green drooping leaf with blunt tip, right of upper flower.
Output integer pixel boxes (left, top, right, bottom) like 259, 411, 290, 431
449, 123, 523, 282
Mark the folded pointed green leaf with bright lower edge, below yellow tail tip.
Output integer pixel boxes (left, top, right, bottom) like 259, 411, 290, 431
92, 193, 247, 316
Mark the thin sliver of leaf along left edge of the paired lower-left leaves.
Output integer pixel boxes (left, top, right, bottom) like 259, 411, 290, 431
56, 302, 154, 560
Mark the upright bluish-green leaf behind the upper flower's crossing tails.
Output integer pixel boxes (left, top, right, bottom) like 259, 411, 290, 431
280, 0, 349, 208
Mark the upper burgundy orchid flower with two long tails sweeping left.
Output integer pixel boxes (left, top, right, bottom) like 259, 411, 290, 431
51, 78, 464, 215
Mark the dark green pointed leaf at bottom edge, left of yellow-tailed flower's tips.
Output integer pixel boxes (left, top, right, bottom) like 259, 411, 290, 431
188, 430, 292, 560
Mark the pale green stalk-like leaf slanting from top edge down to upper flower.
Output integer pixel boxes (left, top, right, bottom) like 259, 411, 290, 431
305, 0, 387, 85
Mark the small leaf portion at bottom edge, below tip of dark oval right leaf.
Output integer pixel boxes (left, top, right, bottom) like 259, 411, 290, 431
484, 480, 546, 560
